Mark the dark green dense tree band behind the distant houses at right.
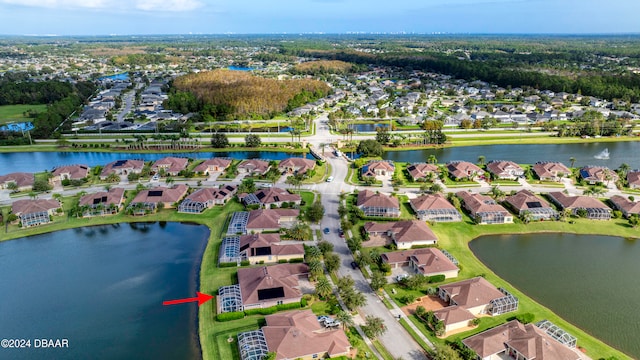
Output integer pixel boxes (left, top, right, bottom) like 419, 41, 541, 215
304, 51, 640, 102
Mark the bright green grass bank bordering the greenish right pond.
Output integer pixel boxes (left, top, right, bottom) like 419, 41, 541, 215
385, 215, 638, 359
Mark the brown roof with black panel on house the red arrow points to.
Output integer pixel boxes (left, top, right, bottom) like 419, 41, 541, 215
238, 264, 309, 306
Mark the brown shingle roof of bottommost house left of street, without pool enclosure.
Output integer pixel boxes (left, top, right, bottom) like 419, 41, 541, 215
262, 310, 351, 359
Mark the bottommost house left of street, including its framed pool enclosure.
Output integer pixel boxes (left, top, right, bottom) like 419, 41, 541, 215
238, 310, 351, 360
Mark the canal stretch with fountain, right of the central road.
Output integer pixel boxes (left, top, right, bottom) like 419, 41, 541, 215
382, 142, 640, 169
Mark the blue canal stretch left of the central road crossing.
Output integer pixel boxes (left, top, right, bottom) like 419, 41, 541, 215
0, 151, 313, 175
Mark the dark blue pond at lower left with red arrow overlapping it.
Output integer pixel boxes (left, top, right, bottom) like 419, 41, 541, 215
0, 223, 209, 360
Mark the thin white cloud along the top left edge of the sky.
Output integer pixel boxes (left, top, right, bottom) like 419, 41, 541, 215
0, 0, 202, 12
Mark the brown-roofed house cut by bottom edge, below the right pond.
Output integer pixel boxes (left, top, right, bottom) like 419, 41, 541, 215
462, 320, 587, 360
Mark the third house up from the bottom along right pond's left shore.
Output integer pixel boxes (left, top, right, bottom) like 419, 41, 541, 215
380, 248, 460, 279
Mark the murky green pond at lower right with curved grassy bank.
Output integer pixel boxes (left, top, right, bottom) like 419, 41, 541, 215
469, 234, 640, 358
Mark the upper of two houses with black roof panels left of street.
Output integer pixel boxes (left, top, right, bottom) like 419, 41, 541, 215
240, 234, 304, 264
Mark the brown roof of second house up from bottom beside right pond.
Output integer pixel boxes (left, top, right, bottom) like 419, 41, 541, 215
440, 277, 504, 309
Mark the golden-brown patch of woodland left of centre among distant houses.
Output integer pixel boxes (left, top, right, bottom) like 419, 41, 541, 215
164, 70, 331, 120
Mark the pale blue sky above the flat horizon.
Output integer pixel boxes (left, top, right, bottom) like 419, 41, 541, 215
0, 0, 640, 35
